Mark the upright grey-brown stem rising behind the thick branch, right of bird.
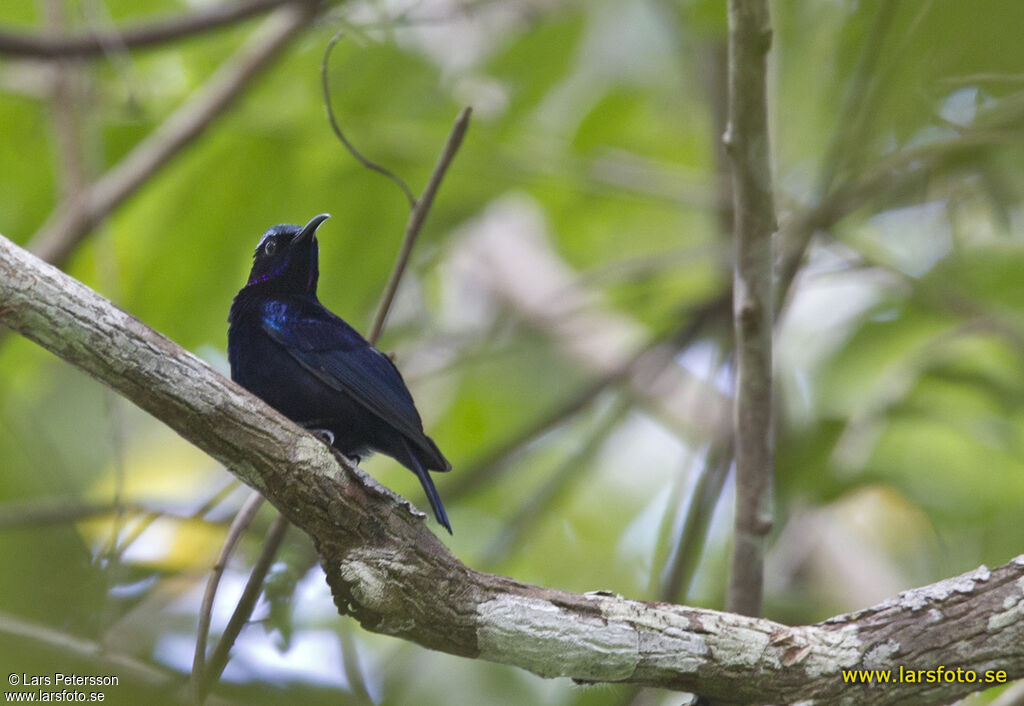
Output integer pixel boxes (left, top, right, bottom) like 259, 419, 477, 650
724, 0, 775, 616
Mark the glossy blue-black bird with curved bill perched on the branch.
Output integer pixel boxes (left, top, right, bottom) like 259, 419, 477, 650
227, 213, 452, 534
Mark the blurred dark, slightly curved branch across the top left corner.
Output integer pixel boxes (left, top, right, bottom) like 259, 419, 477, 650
0, 0, 296, 59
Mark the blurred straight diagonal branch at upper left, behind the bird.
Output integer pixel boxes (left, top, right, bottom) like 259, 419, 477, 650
29, 2, 316, 266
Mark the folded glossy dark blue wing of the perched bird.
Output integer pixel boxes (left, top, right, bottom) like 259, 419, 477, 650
261, 300, 424, 442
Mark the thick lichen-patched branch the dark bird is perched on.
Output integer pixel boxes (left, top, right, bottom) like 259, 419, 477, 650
0, 237, 1024, 704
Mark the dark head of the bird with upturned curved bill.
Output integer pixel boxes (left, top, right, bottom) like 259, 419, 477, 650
246, 213, 331, 294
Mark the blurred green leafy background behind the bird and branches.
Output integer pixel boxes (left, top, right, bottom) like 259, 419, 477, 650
0, 0, 1024, 706
